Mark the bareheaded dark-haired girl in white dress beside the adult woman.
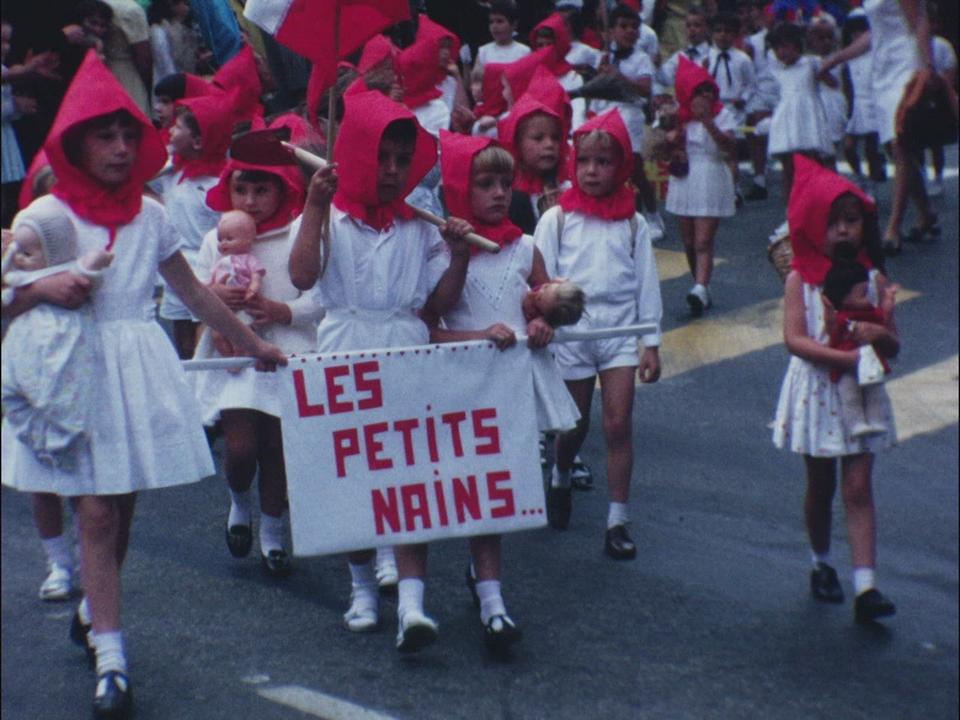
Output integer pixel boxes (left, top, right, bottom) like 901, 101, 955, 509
767, 23, 833, 198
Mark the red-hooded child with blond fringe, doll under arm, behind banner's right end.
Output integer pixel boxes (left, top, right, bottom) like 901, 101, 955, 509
430, 133, 578, 653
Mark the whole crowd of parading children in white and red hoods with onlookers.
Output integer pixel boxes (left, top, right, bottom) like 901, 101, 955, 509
2, 0, 956, 717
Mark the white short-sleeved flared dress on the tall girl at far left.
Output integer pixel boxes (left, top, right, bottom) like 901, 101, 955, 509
2, 195, 213, 496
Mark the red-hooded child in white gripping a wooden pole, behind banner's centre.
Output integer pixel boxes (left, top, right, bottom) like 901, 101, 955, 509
289, 91, 472, 652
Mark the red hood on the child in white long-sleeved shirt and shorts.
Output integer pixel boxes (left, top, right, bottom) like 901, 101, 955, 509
560, 108, 637, 220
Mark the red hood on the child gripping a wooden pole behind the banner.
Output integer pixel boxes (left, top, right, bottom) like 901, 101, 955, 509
333, 91, 437, 230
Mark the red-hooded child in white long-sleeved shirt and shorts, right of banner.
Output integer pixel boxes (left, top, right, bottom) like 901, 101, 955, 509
534, 110, 662, 560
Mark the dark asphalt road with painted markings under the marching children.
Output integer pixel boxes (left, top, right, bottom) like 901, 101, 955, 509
0, 151, 958, 720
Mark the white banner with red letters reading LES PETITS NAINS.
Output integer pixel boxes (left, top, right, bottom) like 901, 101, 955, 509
281, 341, 546, 556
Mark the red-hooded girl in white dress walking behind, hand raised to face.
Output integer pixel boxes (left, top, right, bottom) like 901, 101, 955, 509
666, 58, 737, 317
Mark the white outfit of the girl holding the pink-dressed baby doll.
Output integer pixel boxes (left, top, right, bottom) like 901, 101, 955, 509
192, 219, 323, 425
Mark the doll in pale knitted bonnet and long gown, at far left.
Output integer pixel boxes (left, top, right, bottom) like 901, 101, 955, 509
0, 205, 113, 470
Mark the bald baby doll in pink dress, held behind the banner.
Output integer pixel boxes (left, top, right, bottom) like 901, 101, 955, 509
209, 210, 267, 357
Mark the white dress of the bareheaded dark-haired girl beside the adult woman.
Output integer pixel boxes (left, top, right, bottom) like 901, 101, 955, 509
767, 55, 833, 155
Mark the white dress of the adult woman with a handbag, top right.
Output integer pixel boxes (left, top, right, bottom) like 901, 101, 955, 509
863, 0, 920, 143
